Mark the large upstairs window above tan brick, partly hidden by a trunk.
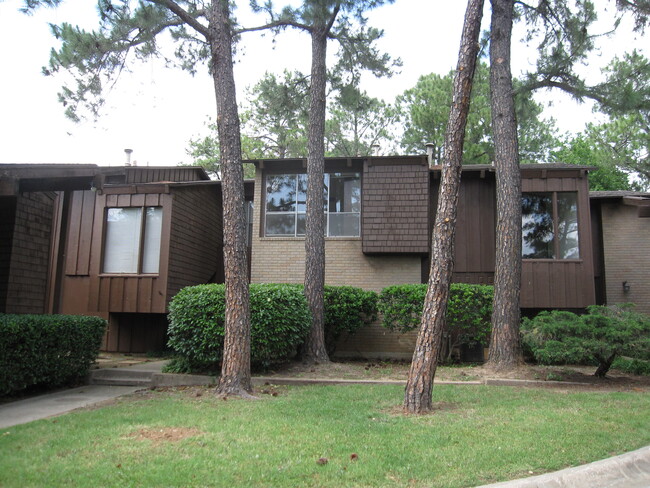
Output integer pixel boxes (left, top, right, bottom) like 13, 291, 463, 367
264, 173, 361, 237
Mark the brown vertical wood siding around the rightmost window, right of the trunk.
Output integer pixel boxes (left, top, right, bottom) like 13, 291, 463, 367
521, 172, 596, 308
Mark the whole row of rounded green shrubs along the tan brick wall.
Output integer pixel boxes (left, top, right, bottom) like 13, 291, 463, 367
167, 284, 492, 374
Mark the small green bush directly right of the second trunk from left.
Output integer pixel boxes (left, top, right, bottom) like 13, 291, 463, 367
325, 286, 377, 355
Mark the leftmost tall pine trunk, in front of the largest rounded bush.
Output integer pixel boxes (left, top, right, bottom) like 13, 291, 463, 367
210, 0, 252, 396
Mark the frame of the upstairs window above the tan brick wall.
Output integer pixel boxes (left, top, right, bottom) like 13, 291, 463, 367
260, 170, 362, 239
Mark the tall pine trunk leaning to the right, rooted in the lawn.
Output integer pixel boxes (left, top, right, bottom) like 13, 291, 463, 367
404, 0, 483, 413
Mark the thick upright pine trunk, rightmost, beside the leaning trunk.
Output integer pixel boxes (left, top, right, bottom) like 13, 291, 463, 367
488, 0, 523, 370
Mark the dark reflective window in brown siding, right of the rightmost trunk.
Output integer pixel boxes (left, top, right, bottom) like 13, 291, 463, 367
521, 192, 580, 259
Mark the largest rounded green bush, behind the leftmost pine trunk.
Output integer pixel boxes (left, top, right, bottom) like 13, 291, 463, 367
168, 284, 310, 373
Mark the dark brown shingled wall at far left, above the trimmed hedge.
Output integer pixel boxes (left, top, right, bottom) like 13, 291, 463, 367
5, 193, 54, 313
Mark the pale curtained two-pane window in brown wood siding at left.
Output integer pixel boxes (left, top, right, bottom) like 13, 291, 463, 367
103, 207, 162, 274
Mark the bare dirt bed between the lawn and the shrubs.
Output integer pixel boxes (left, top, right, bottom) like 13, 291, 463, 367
264, 361, 650, 392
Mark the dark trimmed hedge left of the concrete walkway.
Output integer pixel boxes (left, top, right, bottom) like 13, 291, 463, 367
0, 314, 106, 395
